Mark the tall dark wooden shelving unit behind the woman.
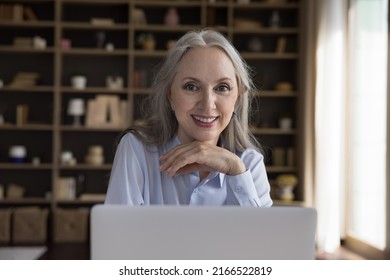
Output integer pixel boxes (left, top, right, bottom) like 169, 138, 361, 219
0, 0, 305, 244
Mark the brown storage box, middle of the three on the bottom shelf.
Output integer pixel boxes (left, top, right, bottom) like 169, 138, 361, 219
12, 207, 49, 244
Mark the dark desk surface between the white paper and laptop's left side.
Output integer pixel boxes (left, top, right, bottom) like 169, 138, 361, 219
39, 243, 90, 260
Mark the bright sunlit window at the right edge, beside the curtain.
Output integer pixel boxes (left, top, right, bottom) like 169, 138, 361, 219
346, 0, 388, 254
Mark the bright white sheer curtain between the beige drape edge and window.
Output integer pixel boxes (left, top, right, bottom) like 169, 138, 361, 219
314, 0, 348, 252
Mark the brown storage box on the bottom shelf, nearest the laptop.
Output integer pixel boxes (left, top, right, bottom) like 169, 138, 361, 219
53, 208, 89, 242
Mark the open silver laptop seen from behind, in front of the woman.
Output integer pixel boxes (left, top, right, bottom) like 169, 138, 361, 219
90, 205, 317, 260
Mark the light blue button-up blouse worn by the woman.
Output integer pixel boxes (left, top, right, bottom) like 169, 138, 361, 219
105, 133, 272, 207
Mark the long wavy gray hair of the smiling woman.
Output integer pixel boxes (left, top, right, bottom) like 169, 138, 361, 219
124, 29, 260, 152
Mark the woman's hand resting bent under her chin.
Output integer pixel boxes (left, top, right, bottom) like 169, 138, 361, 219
160, 141, 246, 176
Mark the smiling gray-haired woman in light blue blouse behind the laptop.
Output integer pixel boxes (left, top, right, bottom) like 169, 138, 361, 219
106, 30, 272, 207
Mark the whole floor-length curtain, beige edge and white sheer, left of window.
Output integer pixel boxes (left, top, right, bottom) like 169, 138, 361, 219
304, 0, 348, 252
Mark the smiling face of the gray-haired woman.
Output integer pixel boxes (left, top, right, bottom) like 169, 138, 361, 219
170, 47, 238, 145
